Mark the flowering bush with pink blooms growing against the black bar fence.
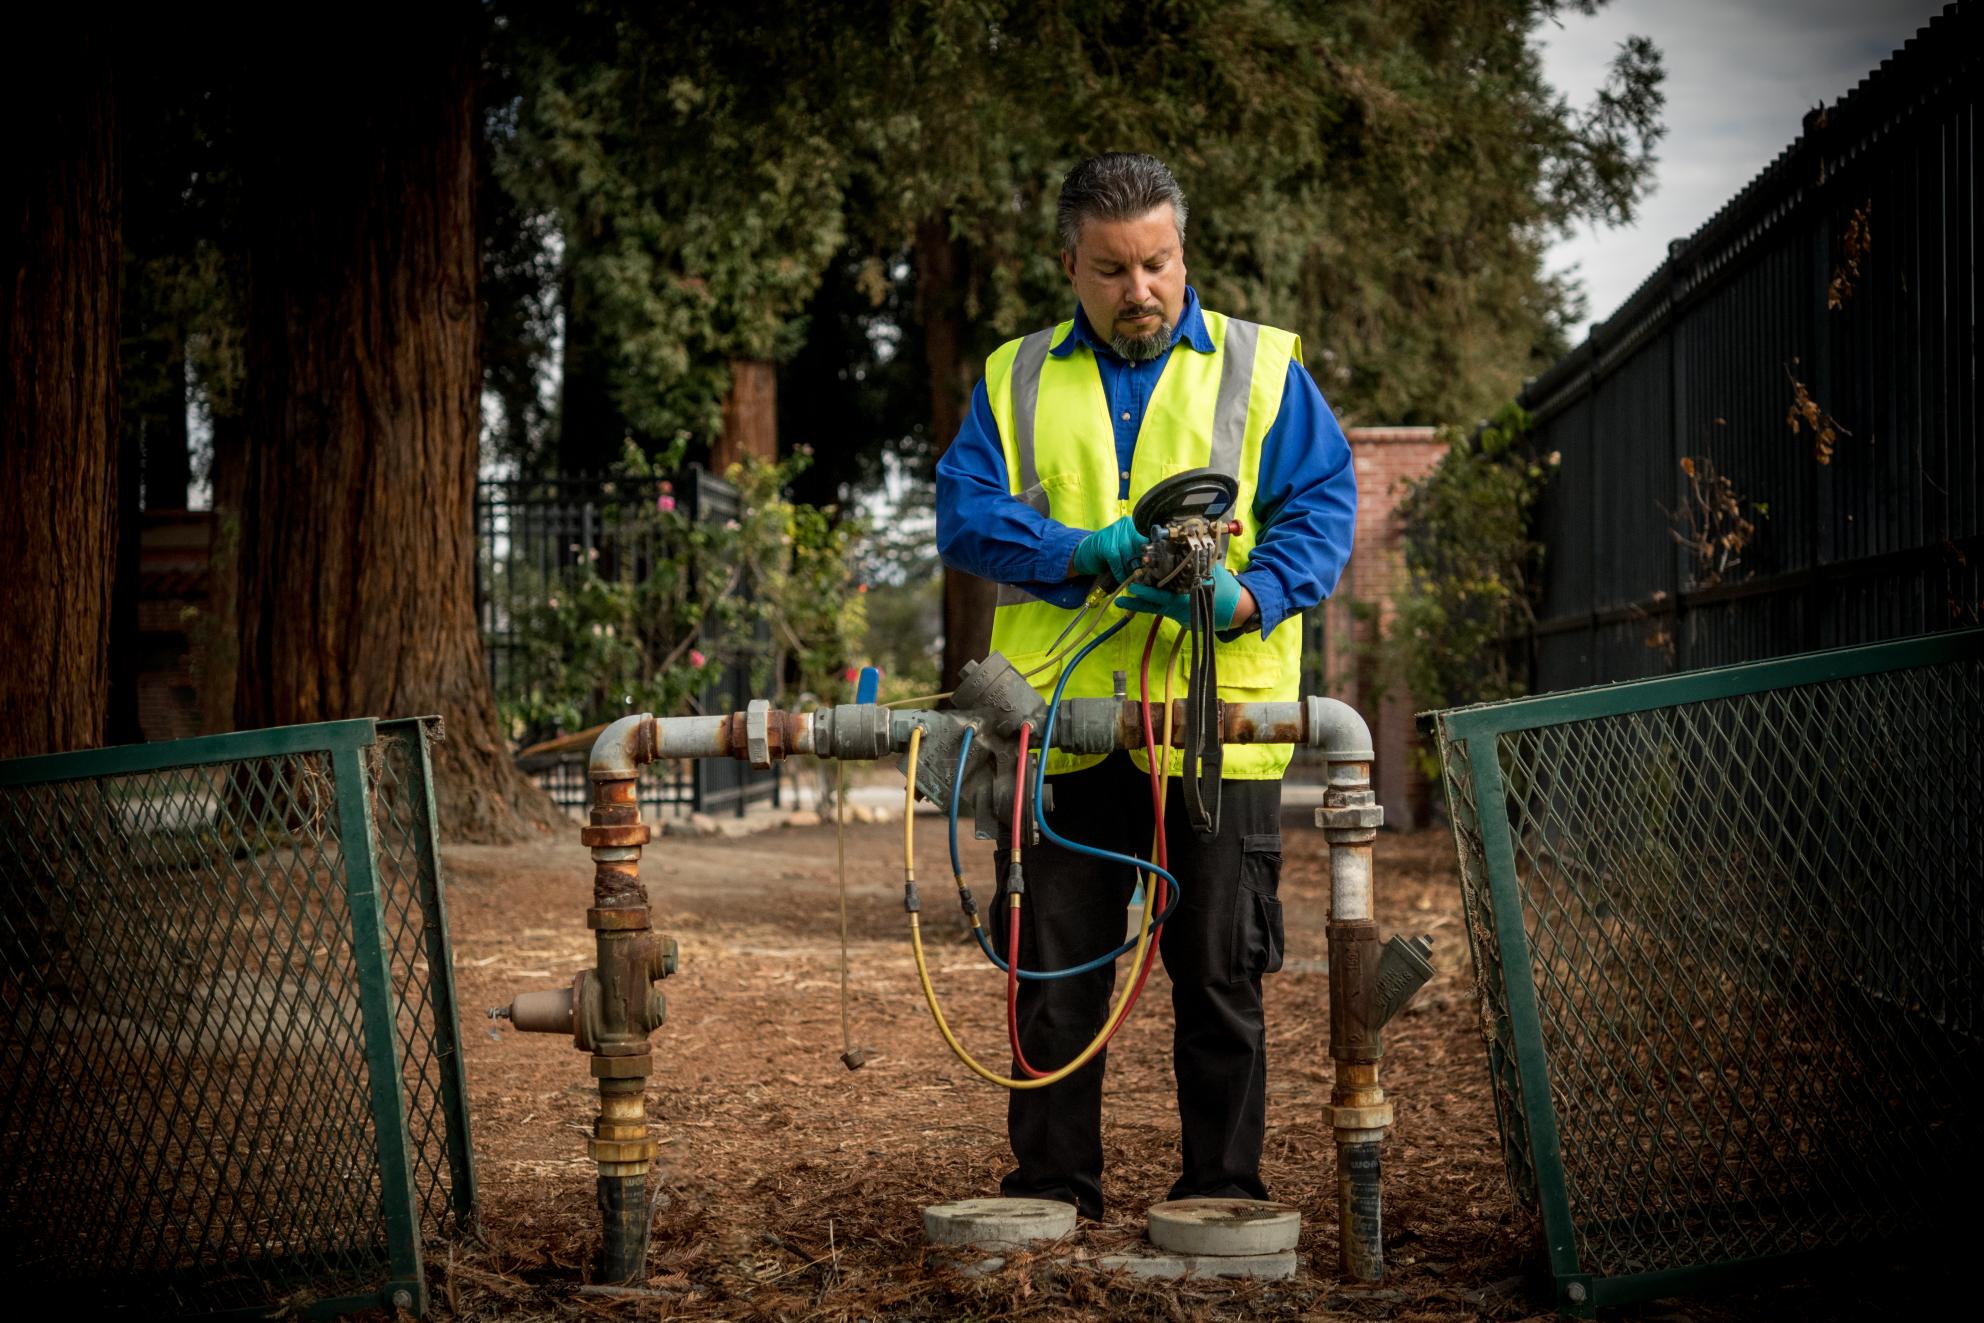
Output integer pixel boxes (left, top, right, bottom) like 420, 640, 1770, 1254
498, 446, 865, 738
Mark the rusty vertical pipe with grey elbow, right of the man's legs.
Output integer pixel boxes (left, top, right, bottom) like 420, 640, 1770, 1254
1309, 698, 1393, 1281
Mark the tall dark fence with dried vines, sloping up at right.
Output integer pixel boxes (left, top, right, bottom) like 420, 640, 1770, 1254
1522, 4, 1984, 692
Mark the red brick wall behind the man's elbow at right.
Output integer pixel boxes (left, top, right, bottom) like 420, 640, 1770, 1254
1317, 426, 1446, 829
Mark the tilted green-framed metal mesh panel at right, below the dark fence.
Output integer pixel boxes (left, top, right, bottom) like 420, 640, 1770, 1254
1434, 631, 1984, 1313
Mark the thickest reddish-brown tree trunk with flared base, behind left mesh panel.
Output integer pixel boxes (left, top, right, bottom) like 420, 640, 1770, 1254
246, 2, 561, 841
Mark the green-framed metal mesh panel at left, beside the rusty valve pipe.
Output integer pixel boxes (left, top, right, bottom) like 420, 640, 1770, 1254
0, 720, 476, 1317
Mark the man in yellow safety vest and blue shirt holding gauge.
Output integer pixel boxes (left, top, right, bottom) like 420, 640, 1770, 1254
936, 153, 1357, 1218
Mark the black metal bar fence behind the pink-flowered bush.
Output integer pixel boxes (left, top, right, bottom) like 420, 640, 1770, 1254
476, 466, 778, 815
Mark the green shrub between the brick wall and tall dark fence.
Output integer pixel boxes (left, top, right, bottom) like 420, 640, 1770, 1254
1393, 405, 1557, 725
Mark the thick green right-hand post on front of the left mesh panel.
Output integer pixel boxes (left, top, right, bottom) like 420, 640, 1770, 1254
331, 740, 427, 1315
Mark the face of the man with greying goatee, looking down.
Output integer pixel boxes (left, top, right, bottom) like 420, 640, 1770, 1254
1061, 202, 1184, 359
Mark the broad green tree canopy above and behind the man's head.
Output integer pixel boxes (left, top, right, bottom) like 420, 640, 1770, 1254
492, 0, 1663, 476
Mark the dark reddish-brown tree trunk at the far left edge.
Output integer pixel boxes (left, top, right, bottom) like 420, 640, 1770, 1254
0, 24, 118, 758
